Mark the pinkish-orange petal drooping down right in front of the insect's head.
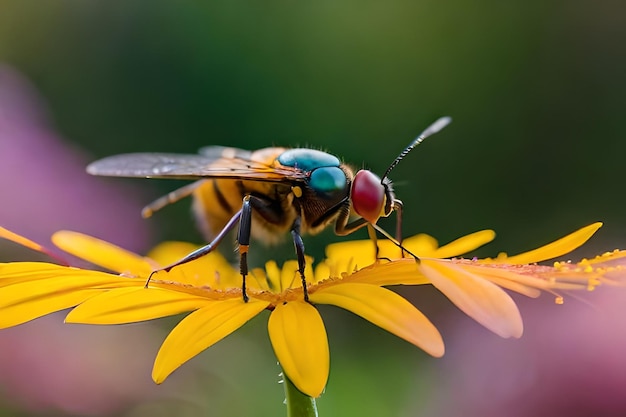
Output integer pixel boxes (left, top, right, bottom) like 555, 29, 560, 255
419, 259, 524, 337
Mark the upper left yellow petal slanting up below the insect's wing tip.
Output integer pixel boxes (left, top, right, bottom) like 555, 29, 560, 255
52, 231, 155, 277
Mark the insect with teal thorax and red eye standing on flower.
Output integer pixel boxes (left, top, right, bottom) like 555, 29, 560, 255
87, 117, 451, 302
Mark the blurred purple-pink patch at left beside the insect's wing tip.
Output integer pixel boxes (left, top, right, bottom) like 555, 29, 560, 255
0, 64, 150, 251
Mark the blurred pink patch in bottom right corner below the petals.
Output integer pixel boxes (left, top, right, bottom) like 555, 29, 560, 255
416, 287, 626, 417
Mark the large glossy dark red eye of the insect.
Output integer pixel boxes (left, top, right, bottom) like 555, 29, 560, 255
350, 170, 385, 223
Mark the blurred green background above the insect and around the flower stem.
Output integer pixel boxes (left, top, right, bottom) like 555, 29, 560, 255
0, 0, 626, 416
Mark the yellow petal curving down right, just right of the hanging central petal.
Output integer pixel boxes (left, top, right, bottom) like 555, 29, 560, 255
310, 283, 444, 357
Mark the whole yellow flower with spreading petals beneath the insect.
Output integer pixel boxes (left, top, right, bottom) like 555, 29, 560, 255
0, 223, 626, 397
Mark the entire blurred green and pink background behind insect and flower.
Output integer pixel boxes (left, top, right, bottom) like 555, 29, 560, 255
0, 0, 626, 417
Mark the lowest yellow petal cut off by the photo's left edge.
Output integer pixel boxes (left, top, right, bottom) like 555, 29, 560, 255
0, 267, 136, 328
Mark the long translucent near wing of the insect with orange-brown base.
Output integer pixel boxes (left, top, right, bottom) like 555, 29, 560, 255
87, 152, 306, 182
